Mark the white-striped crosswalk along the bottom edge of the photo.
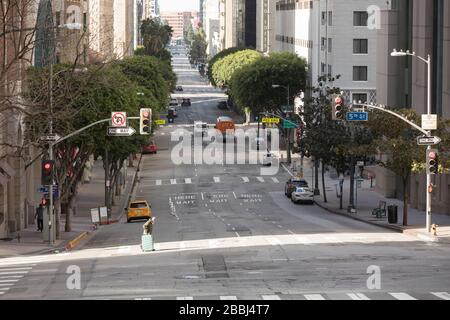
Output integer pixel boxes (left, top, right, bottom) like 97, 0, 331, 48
134, 291, 450, 301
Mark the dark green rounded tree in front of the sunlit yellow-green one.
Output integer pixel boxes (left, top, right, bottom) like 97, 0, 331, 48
229, 52, 307, 114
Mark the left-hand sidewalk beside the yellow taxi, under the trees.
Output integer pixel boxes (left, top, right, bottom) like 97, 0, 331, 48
0, 159, 139, 258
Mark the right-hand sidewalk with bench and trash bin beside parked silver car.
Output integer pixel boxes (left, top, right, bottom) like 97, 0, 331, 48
282, 159, 450, 243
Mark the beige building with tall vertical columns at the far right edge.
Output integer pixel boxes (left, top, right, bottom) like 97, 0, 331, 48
377, 0, 450, 214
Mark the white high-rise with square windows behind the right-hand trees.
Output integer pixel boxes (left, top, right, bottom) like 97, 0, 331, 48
275, 0, 386, 102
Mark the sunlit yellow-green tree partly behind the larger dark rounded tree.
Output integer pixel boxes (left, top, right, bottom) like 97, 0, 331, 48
212, 49, 262, 88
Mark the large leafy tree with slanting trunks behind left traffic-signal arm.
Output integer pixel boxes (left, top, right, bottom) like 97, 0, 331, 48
26, 65, 143, 234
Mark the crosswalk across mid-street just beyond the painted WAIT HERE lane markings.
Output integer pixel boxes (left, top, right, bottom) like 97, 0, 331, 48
141, 177, 281, 187
